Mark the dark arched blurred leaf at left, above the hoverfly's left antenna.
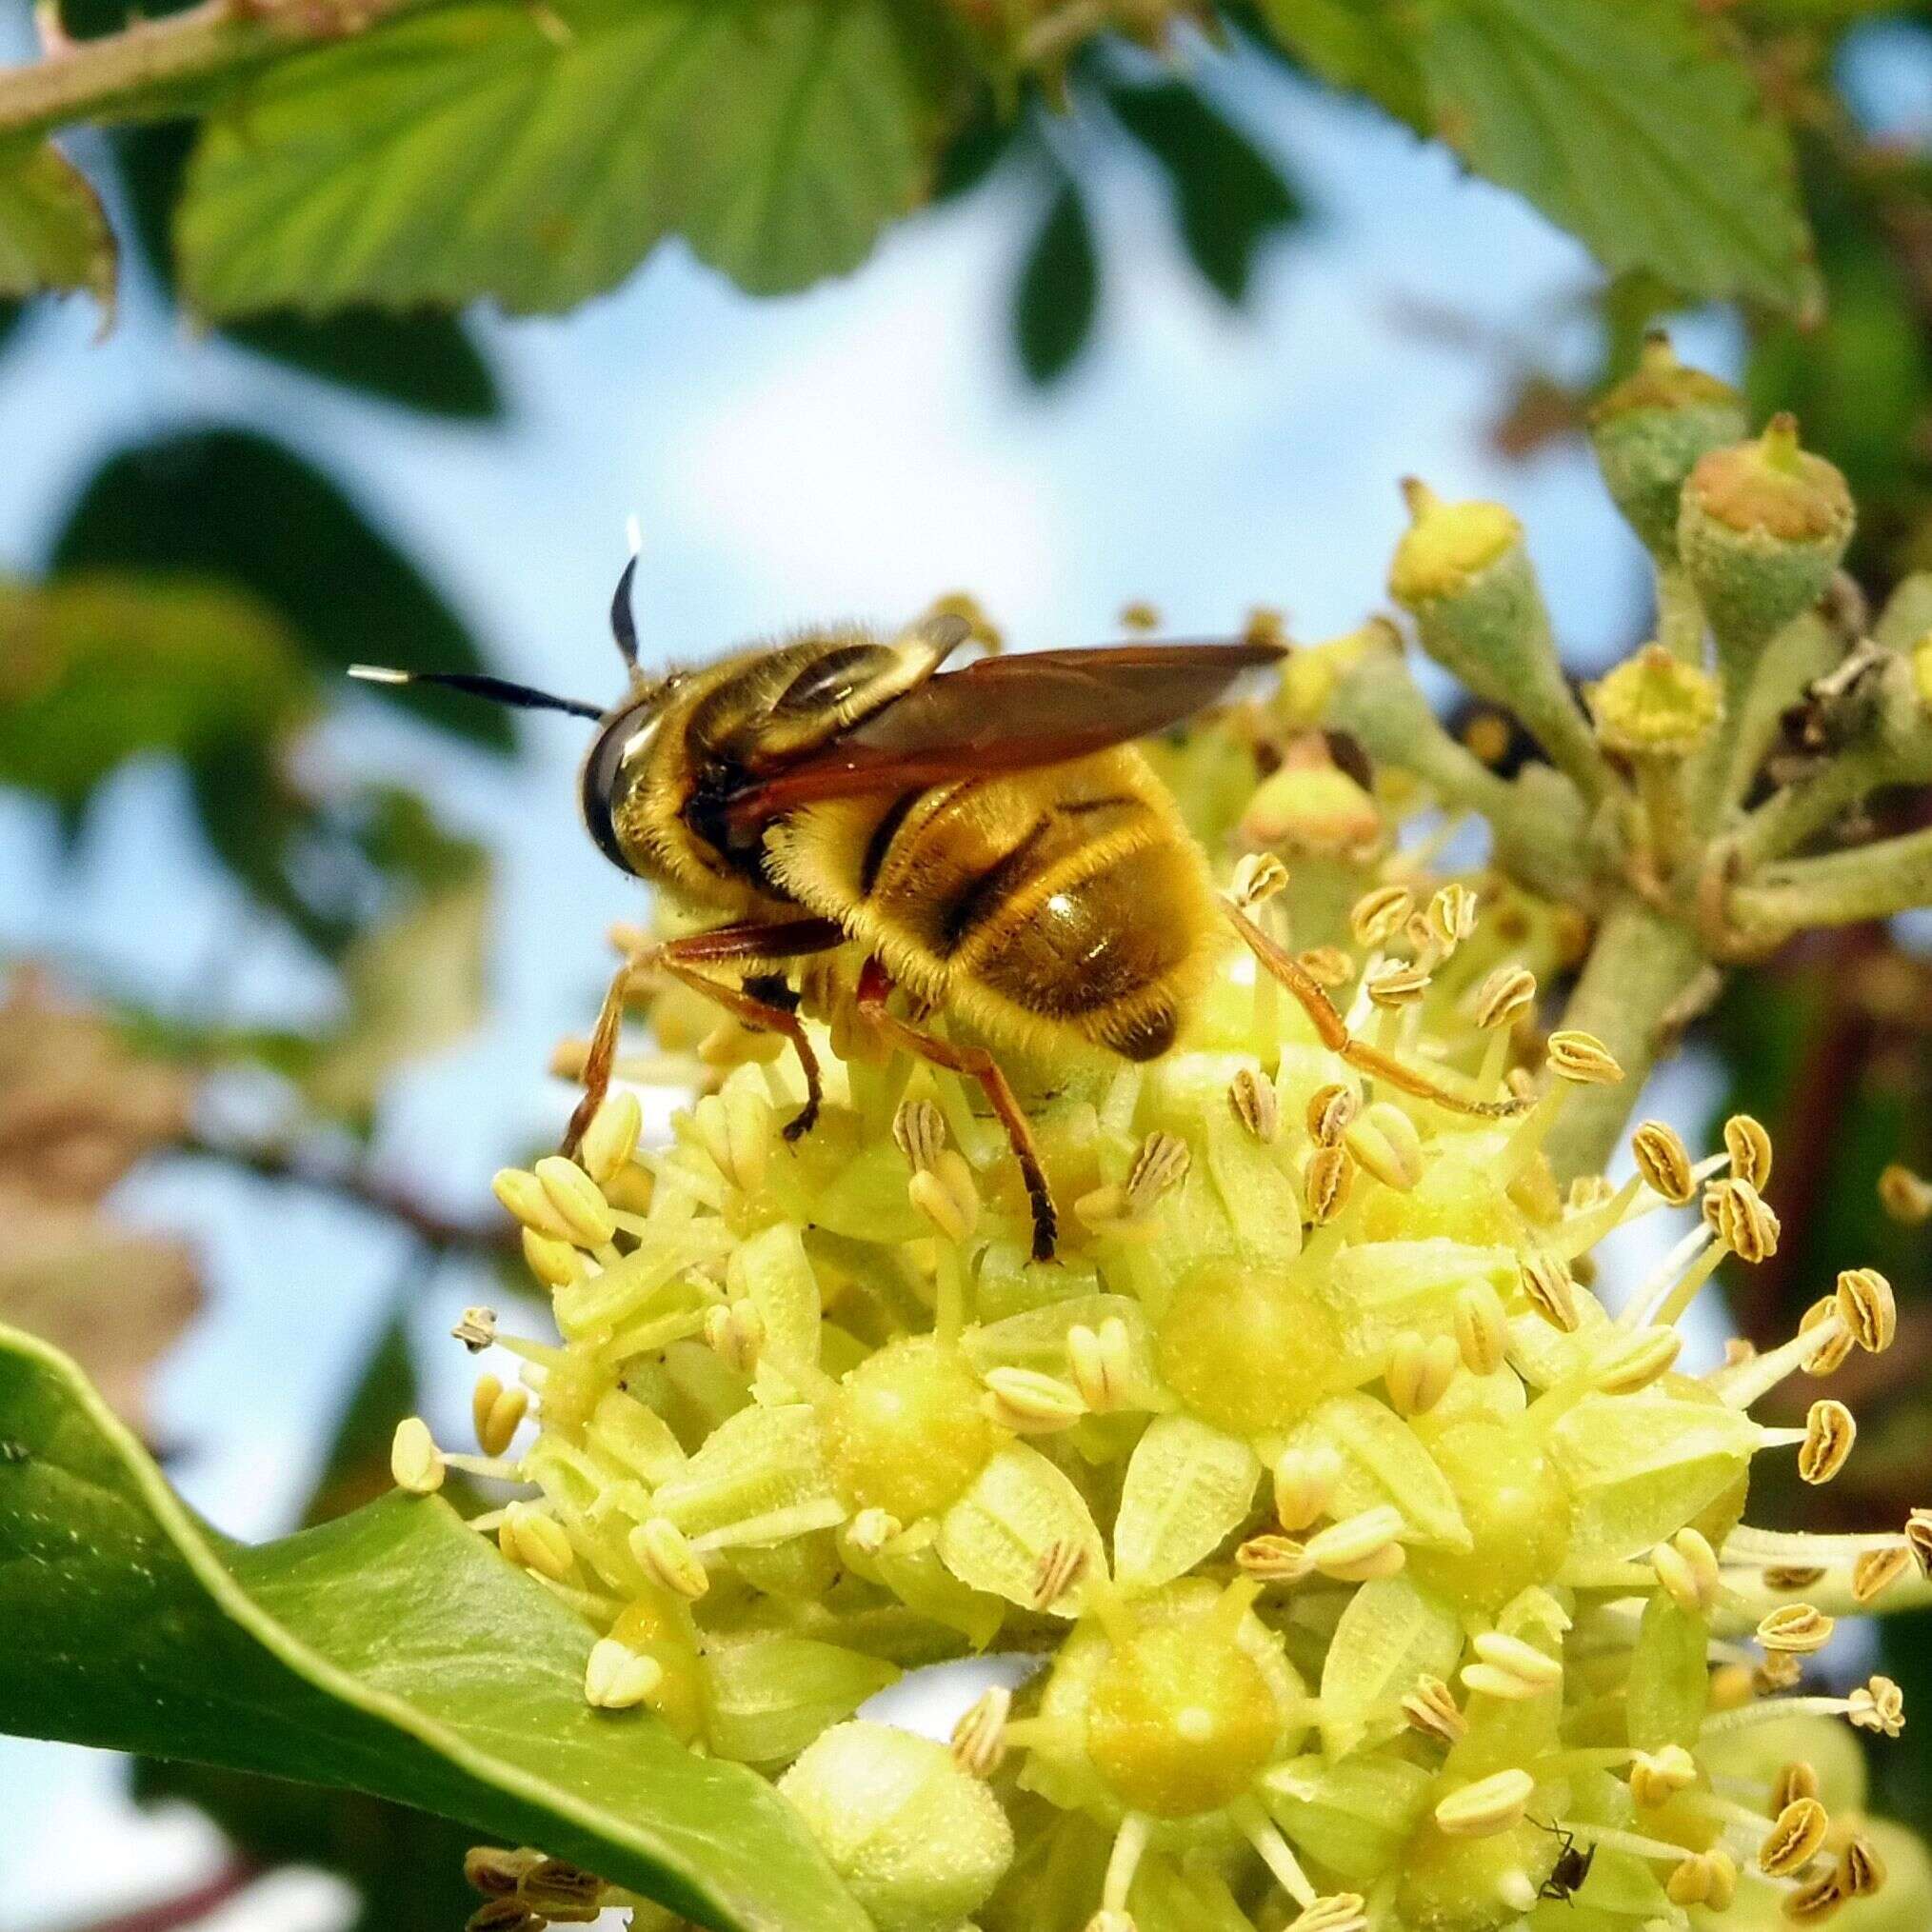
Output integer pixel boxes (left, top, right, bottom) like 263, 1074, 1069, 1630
52, 428, 514, 751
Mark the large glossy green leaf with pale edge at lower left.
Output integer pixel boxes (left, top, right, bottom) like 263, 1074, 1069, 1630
0, 1329, 866, 1932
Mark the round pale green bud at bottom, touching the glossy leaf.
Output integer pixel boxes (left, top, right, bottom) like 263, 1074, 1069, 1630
779, 1720, 1012, 1932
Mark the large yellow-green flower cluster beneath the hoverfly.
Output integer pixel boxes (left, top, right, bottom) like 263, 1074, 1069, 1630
396, 784, 1932, 1932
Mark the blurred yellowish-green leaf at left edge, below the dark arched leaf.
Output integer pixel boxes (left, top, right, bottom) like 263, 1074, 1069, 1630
0, 572, 315, 807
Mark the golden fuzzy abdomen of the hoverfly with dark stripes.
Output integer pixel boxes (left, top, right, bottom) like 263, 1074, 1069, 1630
767, 747, 1213, 1061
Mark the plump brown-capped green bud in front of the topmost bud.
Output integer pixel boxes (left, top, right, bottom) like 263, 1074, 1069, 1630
1677, 415, 1853, 651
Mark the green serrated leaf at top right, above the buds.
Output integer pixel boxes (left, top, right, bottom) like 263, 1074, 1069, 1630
1422, 0, 1816, 309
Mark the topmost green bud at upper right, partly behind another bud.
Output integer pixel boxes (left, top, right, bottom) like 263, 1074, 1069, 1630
1590, 332, 1748, 562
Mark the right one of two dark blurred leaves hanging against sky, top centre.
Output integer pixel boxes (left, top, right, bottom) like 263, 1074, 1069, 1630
1107, 81, 1303, 304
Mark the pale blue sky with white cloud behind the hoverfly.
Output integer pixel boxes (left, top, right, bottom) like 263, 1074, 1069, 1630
0, 37, 1769, 1928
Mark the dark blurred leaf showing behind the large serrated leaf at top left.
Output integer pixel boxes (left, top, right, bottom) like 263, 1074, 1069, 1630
114, 122, 503, 421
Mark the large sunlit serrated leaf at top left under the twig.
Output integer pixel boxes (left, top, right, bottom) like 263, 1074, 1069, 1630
176, 0, 964, 317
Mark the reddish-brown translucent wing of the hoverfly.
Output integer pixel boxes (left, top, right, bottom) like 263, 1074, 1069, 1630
725, 644, 1281, 827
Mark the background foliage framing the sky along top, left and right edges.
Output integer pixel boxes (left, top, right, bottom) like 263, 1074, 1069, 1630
0, 0, 1932, 1924
